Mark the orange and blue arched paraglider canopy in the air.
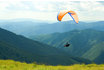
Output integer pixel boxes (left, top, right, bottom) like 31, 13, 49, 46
57, 10, 78, 23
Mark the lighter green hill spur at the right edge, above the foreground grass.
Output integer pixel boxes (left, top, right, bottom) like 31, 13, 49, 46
83, 42, 104, 64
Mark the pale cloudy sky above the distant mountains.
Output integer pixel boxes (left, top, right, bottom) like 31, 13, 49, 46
0, 0, 104, 22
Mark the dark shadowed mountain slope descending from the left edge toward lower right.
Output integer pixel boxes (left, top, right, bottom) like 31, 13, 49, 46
0, 28, 90, 65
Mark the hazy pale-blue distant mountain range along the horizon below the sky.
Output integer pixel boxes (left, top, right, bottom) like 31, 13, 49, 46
0, 19, 104, 37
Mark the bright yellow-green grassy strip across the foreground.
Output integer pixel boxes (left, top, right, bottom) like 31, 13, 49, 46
0, 60, 104, 70
